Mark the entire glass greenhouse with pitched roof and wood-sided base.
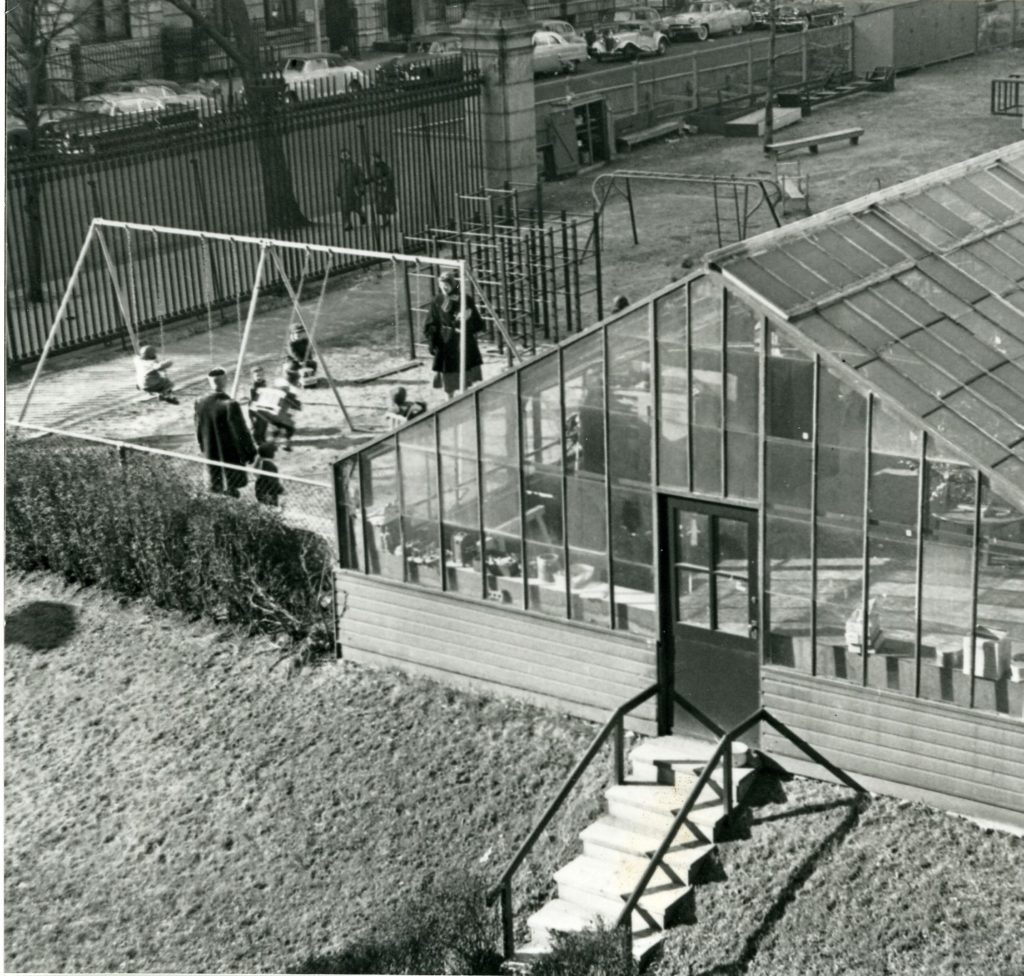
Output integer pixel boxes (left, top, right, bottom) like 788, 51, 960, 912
335, 142, 1024, 828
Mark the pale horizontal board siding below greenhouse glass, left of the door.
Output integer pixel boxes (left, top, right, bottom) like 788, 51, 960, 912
335, 570, 657, 734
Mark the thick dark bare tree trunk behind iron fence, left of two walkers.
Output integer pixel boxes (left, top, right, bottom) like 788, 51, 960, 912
163, 0, 309, 229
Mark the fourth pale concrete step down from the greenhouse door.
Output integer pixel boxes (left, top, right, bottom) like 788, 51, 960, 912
555, 854, 693, 929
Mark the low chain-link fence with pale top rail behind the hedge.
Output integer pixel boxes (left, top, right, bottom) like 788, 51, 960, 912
7, 422, 338, 556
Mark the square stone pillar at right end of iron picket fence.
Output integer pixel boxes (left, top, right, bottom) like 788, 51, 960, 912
453, 0, 537, 187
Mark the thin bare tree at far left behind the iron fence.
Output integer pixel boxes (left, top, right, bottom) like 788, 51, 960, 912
6, 0, 96, 302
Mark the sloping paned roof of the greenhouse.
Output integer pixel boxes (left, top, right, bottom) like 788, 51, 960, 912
709, 141, 1024, 504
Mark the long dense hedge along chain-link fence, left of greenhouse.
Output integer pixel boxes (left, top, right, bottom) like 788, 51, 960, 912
6, 438, 332, 641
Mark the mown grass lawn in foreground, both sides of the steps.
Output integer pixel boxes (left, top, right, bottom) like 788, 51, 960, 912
4, 577, 1024, 976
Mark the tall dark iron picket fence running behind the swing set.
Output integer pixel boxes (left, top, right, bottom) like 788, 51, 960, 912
5, 54, 483, 365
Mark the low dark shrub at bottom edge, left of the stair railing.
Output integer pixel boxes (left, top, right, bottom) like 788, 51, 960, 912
291, 874, 502, 976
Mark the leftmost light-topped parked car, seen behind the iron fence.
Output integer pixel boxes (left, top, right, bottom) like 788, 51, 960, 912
40, 92, 201, 156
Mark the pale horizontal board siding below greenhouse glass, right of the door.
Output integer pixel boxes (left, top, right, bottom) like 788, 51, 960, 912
762, 668, 1024, 828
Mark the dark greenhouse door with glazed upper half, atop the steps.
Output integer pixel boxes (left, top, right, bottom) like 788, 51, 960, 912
662, 496, 760, 737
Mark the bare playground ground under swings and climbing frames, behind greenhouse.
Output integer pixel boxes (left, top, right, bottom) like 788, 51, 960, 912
6, 50, 1022, 495
